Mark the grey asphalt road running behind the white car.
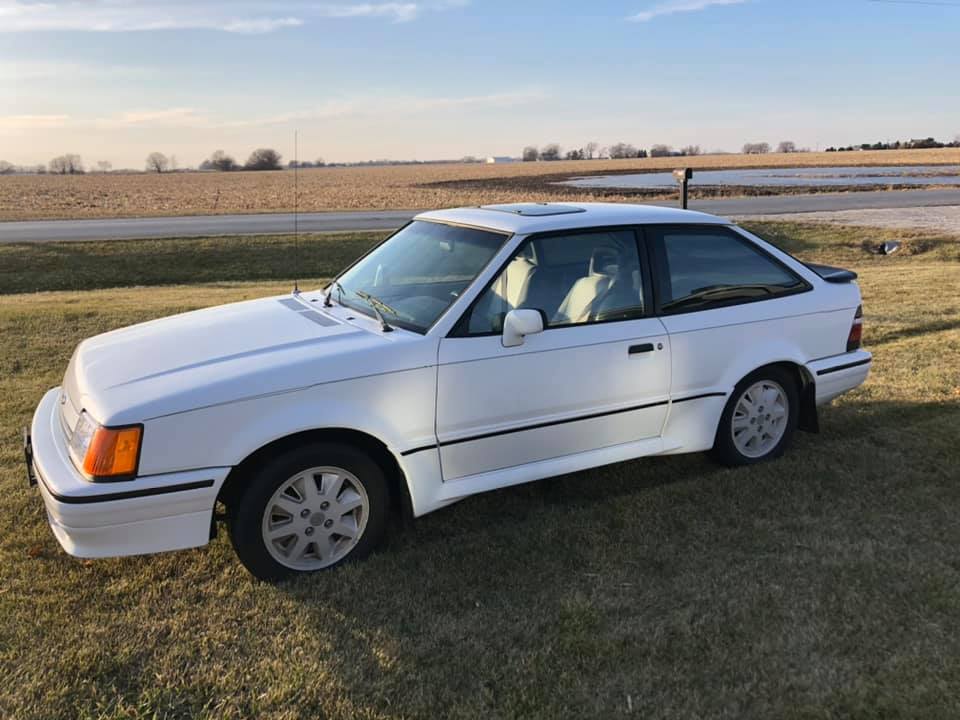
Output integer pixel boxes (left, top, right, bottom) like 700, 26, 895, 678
0, 189, 960, 243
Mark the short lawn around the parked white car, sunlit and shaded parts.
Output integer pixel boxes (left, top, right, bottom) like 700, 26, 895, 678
0, 225, 960, 719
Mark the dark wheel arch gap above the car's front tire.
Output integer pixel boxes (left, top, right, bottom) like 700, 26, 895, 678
217, 428, 413, 518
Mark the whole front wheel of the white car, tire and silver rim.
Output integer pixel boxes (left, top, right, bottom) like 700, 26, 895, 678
229, 443, 390, 582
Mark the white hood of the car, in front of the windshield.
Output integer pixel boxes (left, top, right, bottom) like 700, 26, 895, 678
64, 296, 435, 425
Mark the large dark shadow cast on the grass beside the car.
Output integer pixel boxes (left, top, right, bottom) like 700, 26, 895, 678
251, 402, 960, 717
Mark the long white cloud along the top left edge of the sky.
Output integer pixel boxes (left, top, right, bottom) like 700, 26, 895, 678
0, 0, 467, 34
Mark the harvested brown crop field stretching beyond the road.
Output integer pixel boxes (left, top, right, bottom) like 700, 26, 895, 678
0, 148, 960, 220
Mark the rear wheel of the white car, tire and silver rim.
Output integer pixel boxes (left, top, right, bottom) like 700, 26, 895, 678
711, 367, 800, 467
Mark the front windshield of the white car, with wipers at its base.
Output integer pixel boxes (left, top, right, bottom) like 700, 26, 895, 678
328, 220, 507, 333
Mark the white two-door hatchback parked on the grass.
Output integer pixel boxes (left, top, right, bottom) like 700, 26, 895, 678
24, 203, 871, 579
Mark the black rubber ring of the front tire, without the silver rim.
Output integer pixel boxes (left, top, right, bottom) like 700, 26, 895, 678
229, 443, 390, 582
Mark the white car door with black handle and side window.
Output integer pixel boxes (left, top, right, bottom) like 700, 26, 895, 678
437, 228, 670, 480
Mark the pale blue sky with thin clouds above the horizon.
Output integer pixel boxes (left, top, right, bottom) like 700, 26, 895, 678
0, 0, 960, 168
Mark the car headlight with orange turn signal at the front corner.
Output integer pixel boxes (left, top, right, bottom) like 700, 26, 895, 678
70, 412, 143, 480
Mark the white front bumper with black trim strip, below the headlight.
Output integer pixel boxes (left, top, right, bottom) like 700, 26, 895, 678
30, 388, 230, 558
